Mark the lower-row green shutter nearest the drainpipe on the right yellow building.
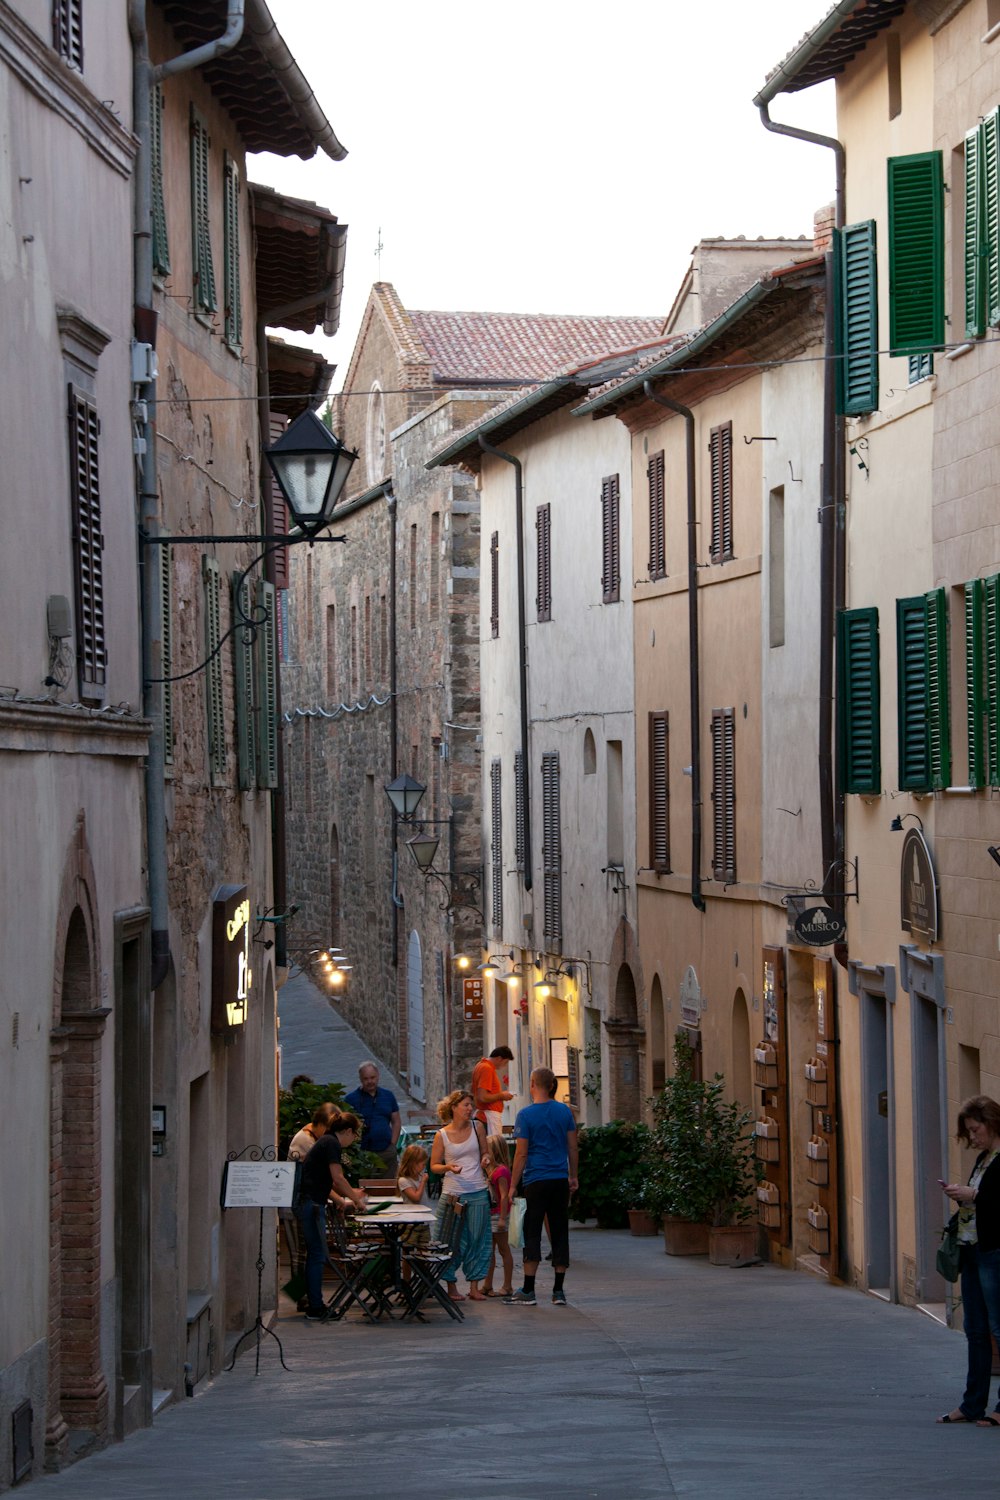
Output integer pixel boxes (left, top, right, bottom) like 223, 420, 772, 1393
837, 608, 882, 797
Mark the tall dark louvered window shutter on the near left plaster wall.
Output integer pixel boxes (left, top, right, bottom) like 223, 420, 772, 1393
69, 384, 108, 702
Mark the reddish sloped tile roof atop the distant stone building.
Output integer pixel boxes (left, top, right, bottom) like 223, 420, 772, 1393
408, 309, 663, 386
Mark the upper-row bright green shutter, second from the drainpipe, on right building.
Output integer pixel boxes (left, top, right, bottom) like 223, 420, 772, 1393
888, 152, 945, 354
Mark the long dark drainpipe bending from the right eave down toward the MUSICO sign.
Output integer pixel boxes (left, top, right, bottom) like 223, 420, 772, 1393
757, 102, 847, 912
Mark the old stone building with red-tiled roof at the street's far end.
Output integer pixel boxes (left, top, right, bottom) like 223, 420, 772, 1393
282, 284, 659, 1101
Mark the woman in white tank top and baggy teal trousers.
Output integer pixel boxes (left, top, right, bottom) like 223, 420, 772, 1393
430, 1089, 493, 1302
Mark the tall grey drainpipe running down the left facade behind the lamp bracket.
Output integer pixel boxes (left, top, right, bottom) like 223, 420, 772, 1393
129, 0, 244, 990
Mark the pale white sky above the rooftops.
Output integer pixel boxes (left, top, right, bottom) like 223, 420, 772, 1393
250, 0, 835, 390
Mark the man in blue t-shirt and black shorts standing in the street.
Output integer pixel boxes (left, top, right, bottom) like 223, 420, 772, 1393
504, 1068, 577, 1308
